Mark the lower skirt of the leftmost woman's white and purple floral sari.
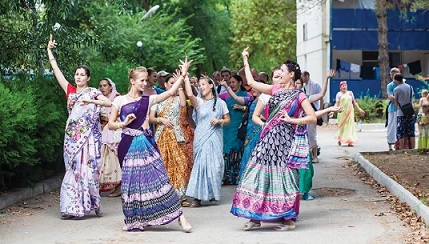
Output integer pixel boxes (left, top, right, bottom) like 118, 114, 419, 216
60, 134, 101, 217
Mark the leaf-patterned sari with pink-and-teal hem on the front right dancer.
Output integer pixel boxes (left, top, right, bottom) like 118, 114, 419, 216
231, 90, 309, 221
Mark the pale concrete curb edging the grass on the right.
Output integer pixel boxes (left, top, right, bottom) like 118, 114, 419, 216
355, 153, 429, 226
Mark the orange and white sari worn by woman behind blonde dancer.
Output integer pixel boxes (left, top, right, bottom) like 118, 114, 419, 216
155, 96, 191, 199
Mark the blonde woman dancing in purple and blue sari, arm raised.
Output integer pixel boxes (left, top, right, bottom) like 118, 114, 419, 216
108, 59, 191, 232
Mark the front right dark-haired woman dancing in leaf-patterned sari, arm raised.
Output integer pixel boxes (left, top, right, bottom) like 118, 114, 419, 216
231, 49, 316, 230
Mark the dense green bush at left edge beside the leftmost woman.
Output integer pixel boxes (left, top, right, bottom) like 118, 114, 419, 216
0, 77, 67, 191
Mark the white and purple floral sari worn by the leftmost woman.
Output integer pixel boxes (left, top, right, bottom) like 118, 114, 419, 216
60, 87, 101, 217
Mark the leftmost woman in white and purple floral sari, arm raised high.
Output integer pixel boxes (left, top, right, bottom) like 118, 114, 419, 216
47, 35, 111, 219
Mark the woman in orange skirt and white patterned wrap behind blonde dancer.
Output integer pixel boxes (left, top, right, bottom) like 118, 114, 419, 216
150, 75, 191, 207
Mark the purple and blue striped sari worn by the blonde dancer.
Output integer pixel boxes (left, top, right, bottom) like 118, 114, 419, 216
113, 96, 182, 231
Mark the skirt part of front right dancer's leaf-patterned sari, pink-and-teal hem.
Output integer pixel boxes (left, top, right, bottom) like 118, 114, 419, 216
231, 124, 299, 221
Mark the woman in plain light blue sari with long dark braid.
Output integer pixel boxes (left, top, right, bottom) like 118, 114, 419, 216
185, 77, 230, 207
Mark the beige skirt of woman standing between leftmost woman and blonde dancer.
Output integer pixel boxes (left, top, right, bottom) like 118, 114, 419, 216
100, 144, 122, 192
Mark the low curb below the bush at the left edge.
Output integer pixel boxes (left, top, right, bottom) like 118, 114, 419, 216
0, 175, 63, 209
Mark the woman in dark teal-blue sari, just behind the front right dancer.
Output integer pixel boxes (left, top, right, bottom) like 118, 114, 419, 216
219, 75, 253, 185
